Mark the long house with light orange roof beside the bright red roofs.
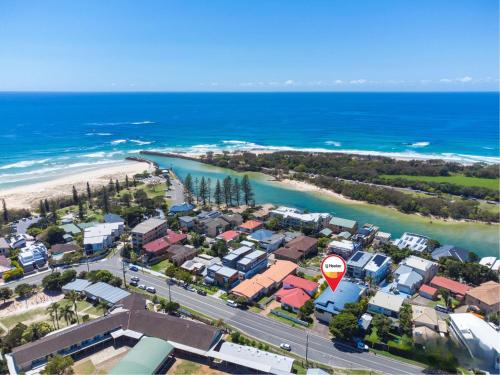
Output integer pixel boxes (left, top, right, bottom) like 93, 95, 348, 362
231, 260, 298, 300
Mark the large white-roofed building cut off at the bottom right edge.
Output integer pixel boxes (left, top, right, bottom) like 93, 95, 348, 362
450, 313, 500, 370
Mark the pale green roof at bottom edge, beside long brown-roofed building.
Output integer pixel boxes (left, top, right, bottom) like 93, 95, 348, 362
108, 336, 174, 375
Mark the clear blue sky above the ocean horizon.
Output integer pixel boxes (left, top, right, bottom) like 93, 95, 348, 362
0, 0, 499, 91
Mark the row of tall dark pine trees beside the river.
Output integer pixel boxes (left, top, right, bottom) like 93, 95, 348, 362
184, 174, 255, 207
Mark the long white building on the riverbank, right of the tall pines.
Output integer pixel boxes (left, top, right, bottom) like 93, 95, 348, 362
269, 206, 331, 232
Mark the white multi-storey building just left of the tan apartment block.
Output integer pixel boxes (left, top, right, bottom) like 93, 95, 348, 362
83, 223, 125, 255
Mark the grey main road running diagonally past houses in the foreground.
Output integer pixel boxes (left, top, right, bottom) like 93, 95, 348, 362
9, 255, 424, 374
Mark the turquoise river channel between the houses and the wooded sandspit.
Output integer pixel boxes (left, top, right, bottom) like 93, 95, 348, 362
148, 156, 500, 257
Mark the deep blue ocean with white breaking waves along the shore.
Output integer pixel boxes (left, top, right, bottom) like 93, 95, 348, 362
0, 93, 500, 189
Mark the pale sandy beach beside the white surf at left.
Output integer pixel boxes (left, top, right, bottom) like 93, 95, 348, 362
0, 161, 153, 208
